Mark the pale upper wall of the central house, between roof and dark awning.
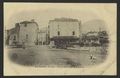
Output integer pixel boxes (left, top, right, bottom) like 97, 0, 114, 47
49, 21, 80, 38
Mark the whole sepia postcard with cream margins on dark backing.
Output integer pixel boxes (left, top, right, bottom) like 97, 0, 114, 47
4, 2, 117, 76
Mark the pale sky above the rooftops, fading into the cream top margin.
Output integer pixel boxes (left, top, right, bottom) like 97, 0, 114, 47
4, 3, 115, 33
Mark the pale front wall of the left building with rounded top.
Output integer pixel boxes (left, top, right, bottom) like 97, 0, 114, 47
19, 23, 38, 45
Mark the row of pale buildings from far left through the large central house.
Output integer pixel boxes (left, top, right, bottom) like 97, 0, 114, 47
6, 18, 109, 48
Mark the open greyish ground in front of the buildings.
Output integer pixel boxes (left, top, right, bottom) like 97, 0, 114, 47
7, 46, 107, 67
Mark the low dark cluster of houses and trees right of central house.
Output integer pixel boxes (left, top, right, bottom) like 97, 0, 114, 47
80, 31, 109, 46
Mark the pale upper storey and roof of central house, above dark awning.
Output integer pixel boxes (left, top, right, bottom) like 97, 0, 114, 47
48, 18, 80, 38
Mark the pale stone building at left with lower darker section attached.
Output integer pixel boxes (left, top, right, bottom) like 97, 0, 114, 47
7, 20, 39, 45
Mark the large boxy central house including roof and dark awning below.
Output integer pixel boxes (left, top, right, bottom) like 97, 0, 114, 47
48, 18, 81, 47
